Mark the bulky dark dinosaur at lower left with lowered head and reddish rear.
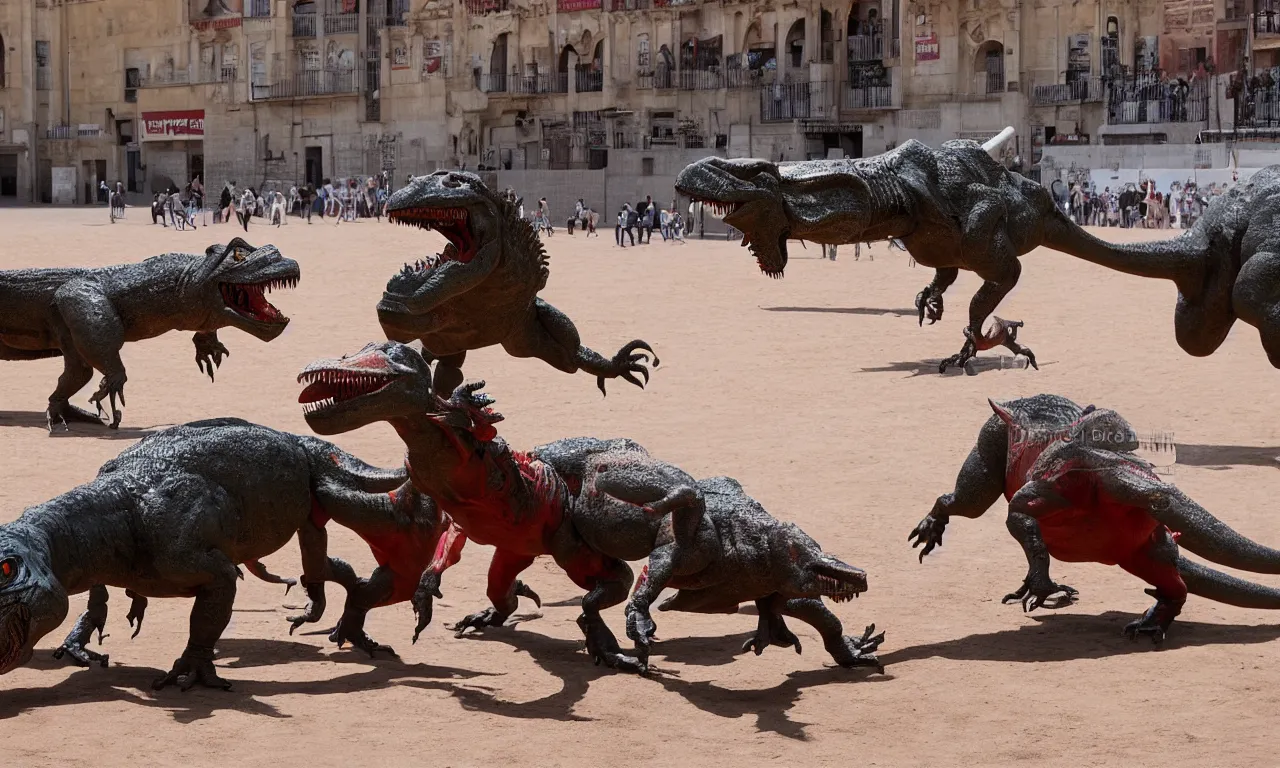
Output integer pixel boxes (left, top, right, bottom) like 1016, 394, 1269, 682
0, 419, 449, 690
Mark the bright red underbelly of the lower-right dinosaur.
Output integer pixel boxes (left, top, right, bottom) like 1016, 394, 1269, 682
1039, 504, 1160, 566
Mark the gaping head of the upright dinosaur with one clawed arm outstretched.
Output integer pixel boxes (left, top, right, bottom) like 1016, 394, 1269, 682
378, 170, 515, 340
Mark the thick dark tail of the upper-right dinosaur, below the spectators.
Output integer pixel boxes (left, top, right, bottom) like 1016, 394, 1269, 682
1043, 203, 1206, 282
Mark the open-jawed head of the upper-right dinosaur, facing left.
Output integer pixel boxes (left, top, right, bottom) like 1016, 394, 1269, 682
676, 157, 791, 278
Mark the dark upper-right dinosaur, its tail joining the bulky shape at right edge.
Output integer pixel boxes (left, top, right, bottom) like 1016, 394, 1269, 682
676, 128, 1280, 371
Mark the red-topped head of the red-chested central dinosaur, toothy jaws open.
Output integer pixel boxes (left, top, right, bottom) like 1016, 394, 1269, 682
298, 342, 440, 435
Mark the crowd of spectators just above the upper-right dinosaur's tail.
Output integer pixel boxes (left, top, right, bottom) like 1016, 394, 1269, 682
1059, 173, 1239, 229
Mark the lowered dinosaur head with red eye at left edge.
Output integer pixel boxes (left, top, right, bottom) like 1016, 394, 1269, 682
0, 526, 68, 675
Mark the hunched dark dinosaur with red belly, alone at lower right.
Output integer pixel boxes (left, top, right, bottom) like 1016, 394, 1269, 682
909, 394, 1280, 643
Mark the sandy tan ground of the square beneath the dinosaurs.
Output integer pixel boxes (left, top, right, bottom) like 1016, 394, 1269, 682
0, 209, 1280, 768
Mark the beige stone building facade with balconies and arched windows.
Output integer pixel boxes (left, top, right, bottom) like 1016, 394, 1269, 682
0, 0, 1280, 207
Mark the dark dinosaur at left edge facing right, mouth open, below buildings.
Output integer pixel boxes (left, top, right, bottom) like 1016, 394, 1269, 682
0, 238, 300, 431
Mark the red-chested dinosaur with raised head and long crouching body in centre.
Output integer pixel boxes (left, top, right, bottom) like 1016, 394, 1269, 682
300, 342, 883, 672
